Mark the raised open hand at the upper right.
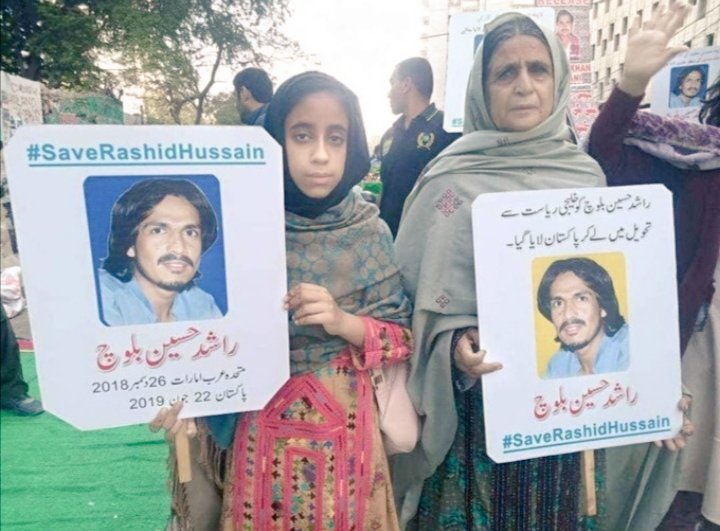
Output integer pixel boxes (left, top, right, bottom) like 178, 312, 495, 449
619, 0, 689, 96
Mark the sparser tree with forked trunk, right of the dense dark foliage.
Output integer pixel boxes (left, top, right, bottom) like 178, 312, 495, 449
119, 0, 293, 123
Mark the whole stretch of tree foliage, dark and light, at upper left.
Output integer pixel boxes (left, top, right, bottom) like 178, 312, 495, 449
0, 0, 297, 123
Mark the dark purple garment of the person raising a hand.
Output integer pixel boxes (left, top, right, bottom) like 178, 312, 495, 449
588, 88, 720, 352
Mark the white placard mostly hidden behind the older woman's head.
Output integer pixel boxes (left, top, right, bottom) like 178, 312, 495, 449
443, 7, 555, 133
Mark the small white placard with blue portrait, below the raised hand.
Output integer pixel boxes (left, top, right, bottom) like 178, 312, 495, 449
650, 46, 720, 121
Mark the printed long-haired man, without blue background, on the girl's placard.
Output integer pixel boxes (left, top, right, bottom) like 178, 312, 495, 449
98, 178, 222, 326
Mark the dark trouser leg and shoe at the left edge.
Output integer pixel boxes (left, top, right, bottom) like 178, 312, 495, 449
0, 304, 44, 416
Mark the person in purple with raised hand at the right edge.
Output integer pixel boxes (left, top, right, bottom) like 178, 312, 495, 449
588, 2, 720, 529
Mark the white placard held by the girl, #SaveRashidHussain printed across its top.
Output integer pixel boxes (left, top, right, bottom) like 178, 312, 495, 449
7, 125, 289, 429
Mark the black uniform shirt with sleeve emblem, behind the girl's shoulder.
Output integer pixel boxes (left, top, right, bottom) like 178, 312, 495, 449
380, 103, 460, 237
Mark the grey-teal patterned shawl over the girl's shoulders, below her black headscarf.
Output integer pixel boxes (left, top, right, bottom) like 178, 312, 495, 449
285, 192, 410, 374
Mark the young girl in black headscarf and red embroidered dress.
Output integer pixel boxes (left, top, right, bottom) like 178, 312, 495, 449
153, 72, 411, 530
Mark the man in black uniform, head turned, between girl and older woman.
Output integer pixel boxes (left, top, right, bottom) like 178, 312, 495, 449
379, 57, 460, 236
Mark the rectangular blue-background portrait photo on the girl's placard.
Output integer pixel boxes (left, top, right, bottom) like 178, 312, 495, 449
83, 175, 227, 326
